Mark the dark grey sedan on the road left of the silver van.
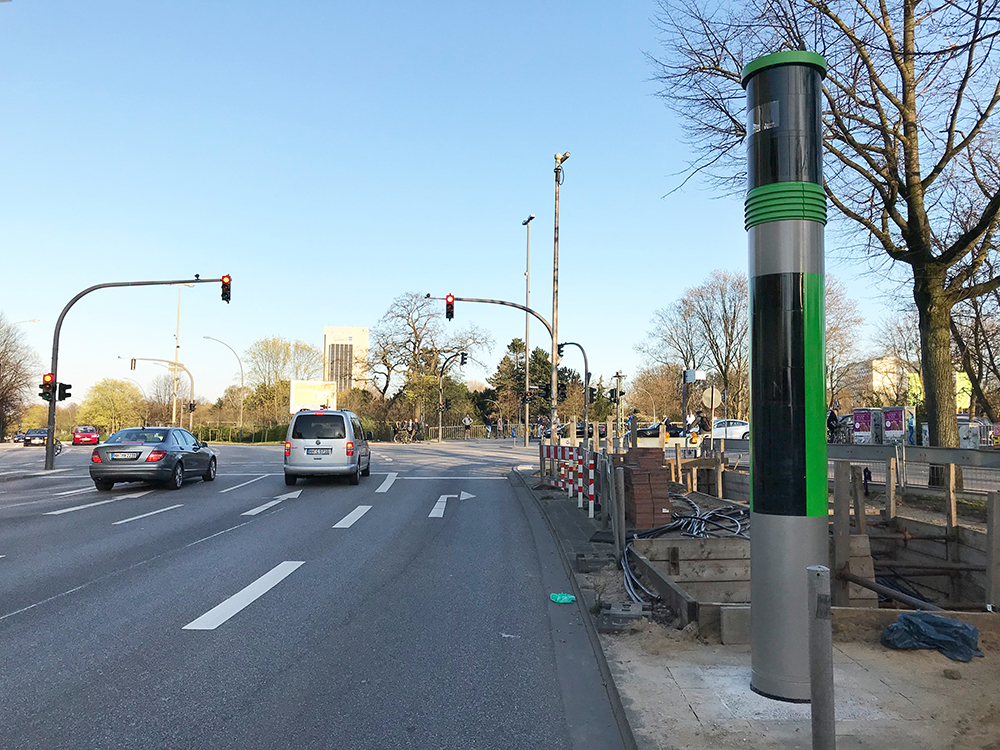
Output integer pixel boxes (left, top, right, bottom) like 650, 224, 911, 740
90, 427, 218, 492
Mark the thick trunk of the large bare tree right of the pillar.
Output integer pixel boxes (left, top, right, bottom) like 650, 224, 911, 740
913, 266, 958, 448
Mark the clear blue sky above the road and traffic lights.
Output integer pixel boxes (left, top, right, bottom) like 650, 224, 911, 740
0, 0, 887, 412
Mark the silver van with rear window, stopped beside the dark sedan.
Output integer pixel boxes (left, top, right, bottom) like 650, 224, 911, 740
285, 409, 372, 486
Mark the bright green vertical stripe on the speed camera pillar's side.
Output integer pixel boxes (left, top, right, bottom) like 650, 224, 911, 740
803, 273, 829, 516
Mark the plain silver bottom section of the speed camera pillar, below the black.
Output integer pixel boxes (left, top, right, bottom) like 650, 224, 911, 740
750, 513, 830, 703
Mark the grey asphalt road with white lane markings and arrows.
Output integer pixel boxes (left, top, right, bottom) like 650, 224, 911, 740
0, 441, 622, 750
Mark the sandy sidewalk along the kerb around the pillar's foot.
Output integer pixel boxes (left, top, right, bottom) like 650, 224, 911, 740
518, 468, 1000, 750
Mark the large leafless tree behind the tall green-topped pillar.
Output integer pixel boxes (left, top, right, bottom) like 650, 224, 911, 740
650, 0, 1000, 446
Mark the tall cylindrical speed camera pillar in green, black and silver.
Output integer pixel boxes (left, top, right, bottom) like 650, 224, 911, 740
742, 51, 829, 701
